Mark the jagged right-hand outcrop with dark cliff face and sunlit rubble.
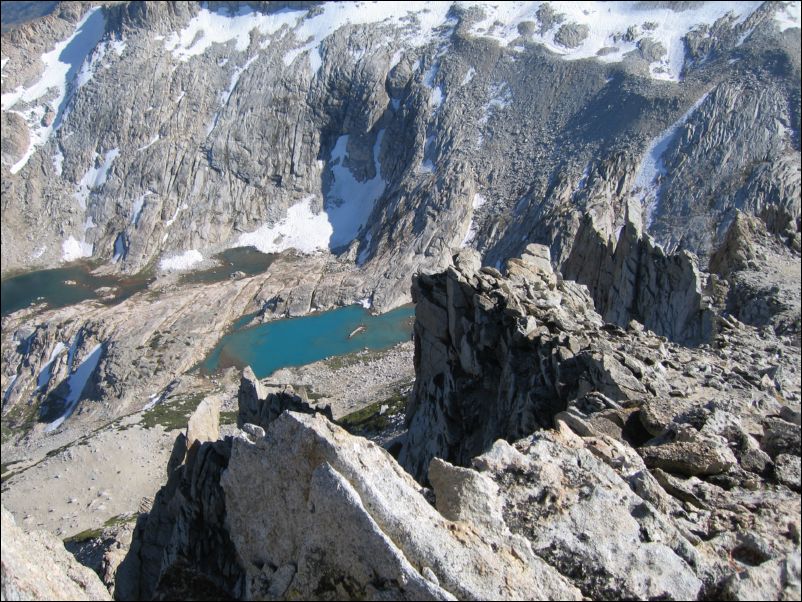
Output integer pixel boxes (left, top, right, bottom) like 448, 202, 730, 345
399, 245, 800, 599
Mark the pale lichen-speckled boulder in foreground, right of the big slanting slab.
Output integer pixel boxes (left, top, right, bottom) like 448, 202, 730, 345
474, 433, 702, 600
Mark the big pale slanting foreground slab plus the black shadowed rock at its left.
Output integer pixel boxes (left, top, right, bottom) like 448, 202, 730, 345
128, 412, 580, 600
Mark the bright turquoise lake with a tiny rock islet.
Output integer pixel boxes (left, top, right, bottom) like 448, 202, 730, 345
200, 305, 415, 378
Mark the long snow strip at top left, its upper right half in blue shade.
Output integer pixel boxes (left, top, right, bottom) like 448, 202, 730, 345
0, 7, 106, 174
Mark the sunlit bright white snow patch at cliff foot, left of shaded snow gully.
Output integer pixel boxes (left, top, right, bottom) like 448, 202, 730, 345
234, 196, 332, 253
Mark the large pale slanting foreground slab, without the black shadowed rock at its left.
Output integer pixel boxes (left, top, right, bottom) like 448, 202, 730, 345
221, 412, 579, 599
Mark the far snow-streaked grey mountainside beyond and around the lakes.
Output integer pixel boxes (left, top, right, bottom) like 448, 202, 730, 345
0, 2, 800, 464
